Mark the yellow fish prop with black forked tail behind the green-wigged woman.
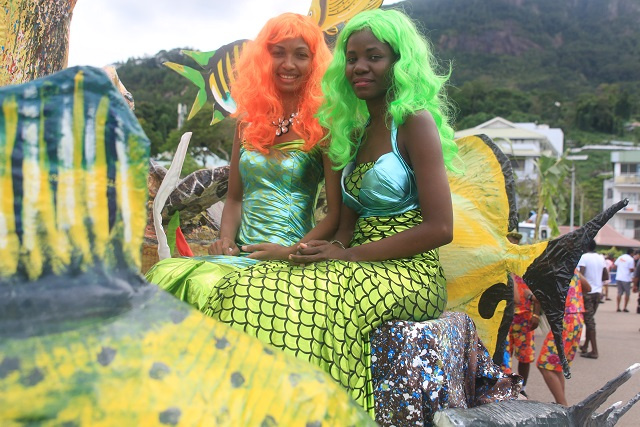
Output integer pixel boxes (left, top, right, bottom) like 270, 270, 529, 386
440, 135, 627, 376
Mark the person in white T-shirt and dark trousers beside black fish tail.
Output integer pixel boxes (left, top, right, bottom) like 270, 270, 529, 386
578, 239, 609, 359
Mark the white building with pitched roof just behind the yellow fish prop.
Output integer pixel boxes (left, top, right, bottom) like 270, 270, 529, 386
455, 117, 564, 181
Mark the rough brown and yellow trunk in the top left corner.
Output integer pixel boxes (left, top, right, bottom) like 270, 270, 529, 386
0, 0, 77, 86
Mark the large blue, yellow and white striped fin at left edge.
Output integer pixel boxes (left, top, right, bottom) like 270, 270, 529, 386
0, 67, 149, 280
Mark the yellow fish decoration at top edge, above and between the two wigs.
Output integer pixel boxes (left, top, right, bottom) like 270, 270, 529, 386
308, 0, 383, 35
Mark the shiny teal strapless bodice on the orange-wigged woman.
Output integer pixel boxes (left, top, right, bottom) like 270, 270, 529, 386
236, 140, 324, 246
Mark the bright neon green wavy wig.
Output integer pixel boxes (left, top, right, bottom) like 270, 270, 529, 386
318, 9, 458, 170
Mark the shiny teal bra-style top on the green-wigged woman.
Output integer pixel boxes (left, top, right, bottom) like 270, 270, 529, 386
342, 124, 420, 217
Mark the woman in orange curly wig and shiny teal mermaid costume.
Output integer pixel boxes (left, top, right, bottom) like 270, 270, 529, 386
147, 13, 341, 309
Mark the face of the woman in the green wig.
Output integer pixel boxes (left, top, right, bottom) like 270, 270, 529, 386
345, 29, 397, 100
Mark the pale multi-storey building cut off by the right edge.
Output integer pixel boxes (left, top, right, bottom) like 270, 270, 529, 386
602, 149, 640, 240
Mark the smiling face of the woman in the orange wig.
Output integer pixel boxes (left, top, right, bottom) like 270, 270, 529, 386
269, 37, 312, 93
